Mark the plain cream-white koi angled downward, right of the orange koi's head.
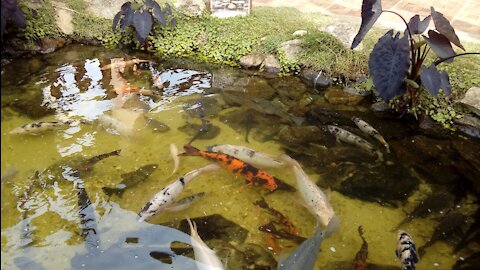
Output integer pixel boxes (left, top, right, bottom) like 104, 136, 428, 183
282, 155, 335, 226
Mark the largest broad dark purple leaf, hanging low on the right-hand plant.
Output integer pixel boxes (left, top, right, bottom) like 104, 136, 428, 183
368, 30, 410, 100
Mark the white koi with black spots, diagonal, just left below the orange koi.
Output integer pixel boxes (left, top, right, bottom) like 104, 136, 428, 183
138, 164, 220, 222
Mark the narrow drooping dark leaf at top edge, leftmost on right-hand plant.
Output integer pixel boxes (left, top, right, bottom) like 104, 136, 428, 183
351, 0, 382, 49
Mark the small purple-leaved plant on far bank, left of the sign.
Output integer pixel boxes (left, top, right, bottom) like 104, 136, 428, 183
112, 0, 177, 46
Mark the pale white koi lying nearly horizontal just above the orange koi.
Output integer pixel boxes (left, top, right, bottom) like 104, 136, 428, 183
207, 144, 285, 168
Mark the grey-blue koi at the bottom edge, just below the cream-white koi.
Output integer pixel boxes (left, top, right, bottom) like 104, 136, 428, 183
277, 218, 339, 270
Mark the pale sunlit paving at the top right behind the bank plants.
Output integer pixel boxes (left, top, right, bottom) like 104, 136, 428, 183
252, 0, 480, 43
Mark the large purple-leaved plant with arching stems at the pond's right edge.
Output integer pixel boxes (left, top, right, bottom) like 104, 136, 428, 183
351, 0, 479, 112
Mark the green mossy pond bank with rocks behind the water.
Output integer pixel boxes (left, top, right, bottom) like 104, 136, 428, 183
6, 0, 480, 135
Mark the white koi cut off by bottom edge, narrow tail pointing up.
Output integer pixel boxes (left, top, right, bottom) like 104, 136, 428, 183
187, 218, 224, 270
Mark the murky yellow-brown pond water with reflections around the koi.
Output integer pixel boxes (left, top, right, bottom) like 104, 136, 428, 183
1, 45, 480, 269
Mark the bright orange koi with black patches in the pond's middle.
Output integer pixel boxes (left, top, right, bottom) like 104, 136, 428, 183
179, 144, 295, 191
